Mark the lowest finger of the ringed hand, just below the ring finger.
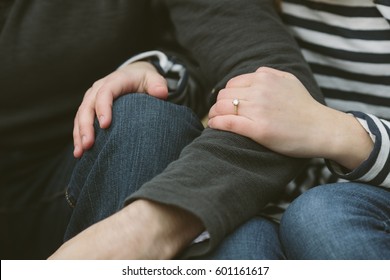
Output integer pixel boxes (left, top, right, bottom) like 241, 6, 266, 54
208, 115, 255, 138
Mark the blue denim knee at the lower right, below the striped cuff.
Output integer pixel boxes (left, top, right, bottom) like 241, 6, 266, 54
280, 183, 390, 260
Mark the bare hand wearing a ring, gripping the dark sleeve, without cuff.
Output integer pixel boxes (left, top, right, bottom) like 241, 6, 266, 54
208, 67, 373, 169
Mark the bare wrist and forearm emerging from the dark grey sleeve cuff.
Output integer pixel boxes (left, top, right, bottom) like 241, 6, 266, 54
49, 200, 204, 260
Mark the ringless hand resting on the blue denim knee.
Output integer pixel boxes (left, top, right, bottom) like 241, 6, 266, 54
73, 62, 168, 158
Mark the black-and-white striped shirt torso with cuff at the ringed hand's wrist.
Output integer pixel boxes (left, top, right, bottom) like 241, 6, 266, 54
258, 0, 390, 222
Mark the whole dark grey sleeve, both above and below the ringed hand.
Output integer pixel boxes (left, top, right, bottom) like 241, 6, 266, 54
127, 0, 322, 255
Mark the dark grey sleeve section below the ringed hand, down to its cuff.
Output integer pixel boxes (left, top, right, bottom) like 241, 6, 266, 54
128, 129, 304, 254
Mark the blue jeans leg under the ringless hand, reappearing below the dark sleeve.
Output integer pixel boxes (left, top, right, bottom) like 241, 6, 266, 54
65, 94, 283, 259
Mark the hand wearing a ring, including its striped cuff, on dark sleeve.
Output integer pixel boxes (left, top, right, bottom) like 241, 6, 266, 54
208, 68, 390, 187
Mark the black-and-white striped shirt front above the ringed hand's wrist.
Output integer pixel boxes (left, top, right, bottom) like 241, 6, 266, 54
282, 0, 390, 119
